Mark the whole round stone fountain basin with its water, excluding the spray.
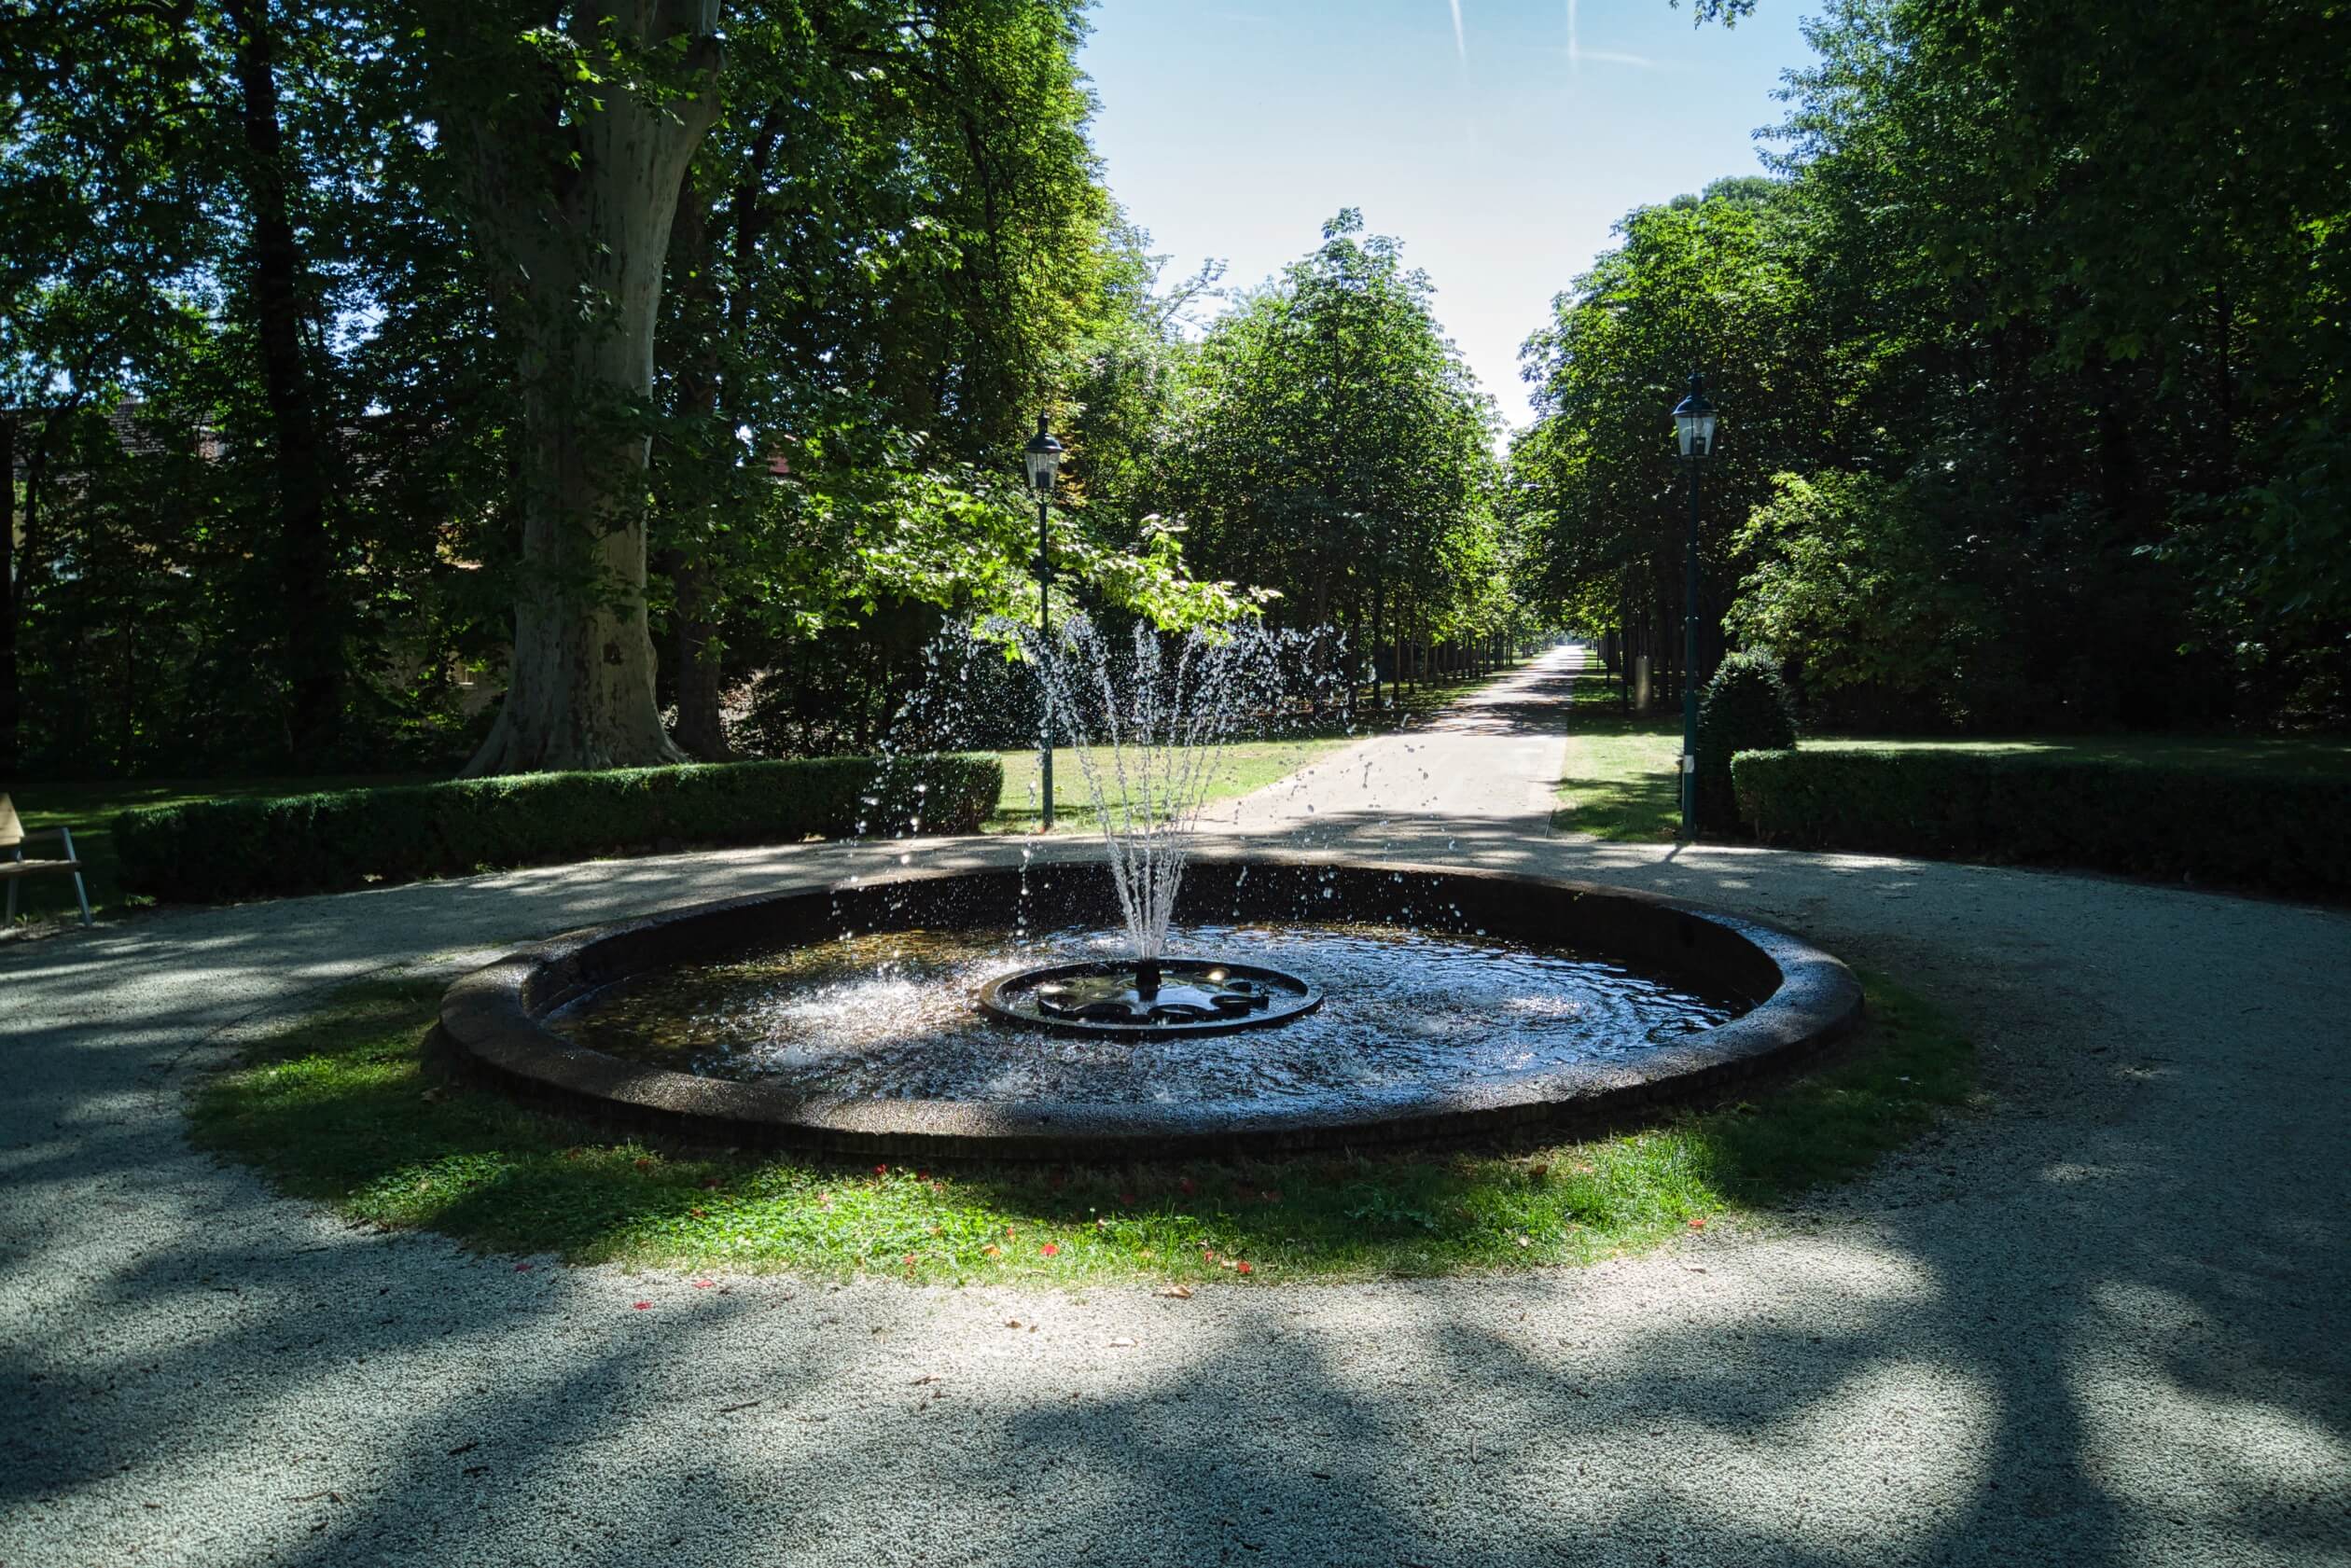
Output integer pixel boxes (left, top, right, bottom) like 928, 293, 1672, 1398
442, 858, 1859, 1159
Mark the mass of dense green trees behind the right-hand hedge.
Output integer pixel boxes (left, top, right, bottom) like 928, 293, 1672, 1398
1509, 0, 2351, 728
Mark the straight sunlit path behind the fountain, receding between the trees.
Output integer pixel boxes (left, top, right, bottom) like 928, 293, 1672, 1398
1203, 646, 1590, 844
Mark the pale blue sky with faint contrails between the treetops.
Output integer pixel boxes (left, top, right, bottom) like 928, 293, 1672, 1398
1081, 0, 1817, 425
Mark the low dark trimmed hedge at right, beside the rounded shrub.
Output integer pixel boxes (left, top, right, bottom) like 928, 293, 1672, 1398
1731, 747, 2351, 895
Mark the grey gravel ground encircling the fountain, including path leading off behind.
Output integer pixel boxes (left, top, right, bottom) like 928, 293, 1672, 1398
0, 644, 2351, 1568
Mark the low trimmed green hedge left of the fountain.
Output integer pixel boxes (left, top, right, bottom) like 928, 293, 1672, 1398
115, 757, 1004, 903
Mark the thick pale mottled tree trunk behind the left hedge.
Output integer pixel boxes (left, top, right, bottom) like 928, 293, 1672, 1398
463, 0, 719, 776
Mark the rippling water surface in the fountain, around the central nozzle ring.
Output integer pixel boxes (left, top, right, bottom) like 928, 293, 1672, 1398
548, 923, 1749, 1107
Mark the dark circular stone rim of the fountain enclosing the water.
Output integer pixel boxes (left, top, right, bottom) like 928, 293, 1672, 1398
439, 851, 1862, 1161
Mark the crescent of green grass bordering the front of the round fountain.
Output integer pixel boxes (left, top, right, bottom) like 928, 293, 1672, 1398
190, 976, 1975, 1284
